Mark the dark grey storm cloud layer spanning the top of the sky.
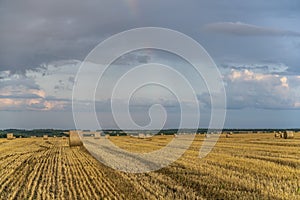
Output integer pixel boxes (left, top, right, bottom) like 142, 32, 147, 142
0, 0, 299, 72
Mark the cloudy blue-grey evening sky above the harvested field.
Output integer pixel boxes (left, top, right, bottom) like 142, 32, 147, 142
0, 0, 300, 129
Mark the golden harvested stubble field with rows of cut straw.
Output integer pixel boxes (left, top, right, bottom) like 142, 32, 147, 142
0, 133, 300, 200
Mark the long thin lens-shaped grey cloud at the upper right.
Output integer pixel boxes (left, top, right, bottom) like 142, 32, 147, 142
204, 22, 300, 37
